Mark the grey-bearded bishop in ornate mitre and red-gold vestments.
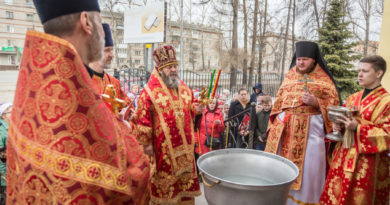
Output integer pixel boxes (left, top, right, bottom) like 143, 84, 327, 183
133, 45, 202, 204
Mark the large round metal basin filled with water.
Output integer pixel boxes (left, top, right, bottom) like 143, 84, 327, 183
197, 149, 299, 205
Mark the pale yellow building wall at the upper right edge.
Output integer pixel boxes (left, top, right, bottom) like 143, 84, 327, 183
378, 0, 390, 91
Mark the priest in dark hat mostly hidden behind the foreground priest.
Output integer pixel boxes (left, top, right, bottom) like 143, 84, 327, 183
87, 23, 131, 106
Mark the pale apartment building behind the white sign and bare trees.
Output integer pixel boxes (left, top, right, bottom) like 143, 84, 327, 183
102, 11, 223, 71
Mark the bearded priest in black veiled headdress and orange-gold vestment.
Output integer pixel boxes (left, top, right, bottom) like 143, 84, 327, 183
265, 41, 339, 205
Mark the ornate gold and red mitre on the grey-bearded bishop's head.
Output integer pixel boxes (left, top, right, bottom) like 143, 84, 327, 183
153, 45, 177, 70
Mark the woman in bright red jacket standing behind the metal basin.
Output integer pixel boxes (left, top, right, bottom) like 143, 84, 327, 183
195, 99, 225, 155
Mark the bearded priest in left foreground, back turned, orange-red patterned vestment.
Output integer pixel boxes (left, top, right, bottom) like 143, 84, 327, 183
7, 0, 150, 205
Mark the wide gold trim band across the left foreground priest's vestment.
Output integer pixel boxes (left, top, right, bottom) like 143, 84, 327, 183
8, 124, 131, 194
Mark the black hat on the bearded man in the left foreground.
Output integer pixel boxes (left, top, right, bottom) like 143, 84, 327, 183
34, 0, 100, 23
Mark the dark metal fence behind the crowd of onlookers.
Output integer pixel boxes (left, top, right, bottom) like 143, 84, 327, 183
114, 68, 280, 97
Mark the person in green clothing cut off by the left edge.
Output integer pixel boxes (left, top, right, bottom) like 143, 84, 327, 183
0, 103, 12, 200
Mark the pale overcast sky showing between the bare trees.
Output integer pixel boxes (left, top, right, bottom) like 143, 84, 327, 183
105, 0, 382, 47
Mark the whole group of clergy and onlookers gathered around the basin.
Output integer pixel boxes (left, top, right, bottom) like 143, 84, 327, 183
0, 0, 390, 205
